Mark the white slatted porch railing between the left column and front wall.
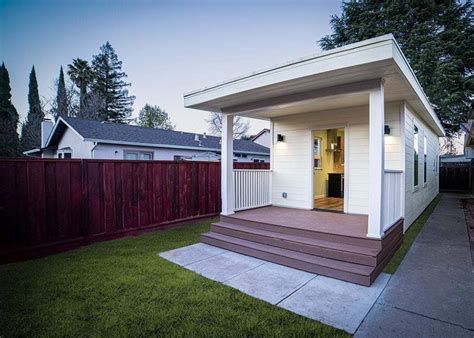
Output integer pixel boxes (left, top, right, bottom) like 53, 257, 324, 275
234, 169, 272, 211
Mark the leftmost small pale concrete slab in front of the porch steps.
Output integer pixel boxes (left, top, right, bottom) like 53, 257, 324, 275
159, 243, 225, 266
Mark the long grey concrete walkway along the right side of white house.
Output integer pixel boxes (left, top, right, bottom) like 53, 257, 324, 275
355, 195, 474, 337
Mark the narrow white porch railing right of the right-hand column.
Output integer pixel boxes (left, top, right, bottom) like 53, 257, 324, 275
382, 170, 404, 231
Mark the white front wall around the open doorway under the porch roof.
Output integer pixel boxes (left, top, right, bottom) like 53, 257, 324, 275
272, 102, 403, 214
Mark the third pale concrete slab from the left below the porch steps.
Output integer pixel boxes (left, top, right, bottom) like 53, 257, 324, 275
224, 263, 316, 304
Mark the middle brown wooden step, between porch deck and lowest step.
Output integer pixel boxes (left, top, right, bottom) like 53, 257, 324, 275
213, 221, 381, 257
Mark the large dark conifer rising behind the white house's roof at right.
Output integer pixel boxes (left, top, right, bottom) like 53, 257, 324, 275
320, 0, 474, 135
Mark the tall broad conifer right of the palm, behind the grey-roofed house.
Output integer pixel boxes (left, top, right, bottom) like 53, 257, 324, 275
92, 42, 135, 122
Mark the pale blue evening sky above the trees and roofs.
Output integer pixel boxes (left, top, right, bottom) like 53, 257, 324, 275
0, 0, 340, 133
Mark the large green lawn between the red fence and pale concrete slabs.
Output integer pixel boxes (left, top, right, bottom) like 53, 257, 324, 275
0, 220, 346, 337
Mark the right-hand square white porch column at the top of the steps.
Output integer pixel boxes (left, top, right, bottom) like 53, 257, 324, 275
367, 80, 385, 238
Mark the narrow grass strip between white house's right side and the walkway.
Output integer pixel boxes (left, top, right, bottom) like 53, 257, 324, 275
383, 195, 441, 274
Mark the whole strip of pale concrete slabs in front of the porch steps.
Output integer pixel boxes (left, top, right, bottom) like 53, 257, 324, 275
160, 243, 390, 334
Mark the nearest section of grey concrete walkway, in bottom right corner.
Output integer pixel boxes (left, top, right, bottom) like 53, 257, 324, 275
354, 304, 473, 338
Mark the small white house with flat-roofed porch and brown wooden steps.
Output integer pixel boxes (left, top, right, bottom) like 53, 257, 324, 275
184, 34, 445, 285
